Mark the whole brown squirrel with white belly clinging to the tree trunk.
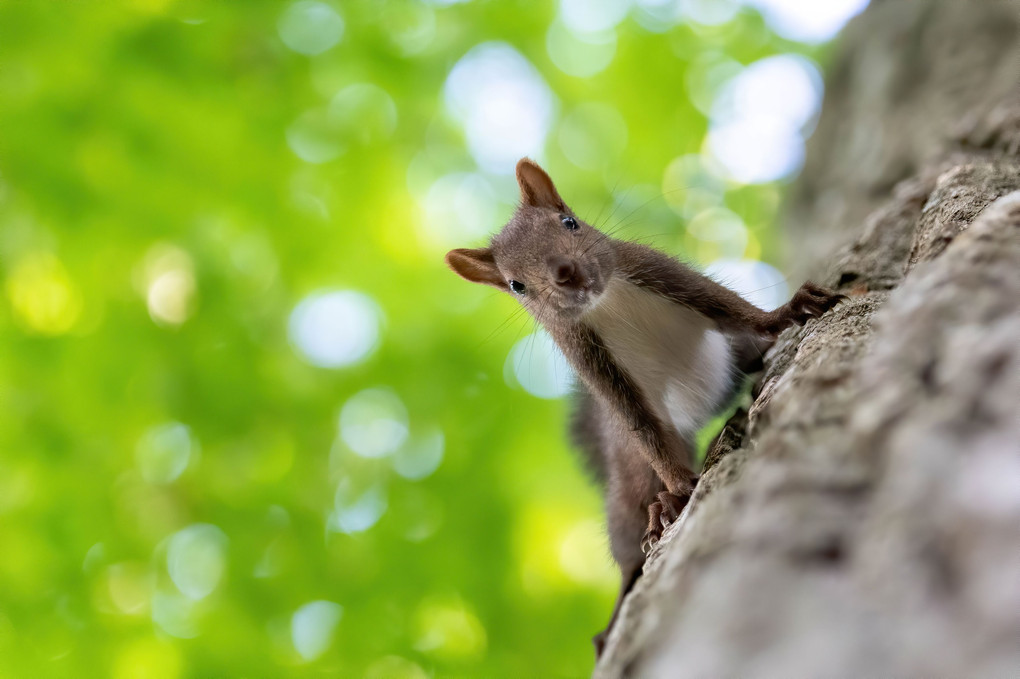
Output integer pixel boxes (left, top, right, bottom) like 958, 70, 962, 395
446, 158, 843, 655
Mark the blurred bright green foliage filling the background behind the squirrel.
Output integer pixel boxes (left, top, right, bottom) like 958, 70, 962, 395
0, 0, 818, 679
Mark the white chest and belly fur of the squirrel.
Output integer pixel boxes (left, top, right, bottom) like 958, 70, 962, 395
584, 279, 735, 437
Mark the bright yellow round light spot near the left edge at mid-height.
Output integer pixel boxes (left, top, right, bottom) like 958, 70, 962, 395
6, 253, 82, 334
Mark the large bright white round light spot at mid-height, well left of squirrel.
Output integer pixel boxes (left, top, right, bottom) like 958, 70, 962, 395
288, 291, 383, 368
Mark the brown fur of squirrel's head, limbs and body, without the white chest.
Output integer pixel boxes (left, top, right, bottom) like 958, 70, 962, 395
447, 158, 840, 652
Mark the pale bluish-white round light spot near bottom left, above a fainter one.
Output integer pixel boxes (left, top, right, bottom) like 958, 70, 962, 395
166, 523, 227, 600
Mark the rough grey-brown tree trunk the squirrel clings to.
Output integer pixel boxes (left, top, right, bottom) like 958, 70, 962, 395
595, 0, 1020, 679
